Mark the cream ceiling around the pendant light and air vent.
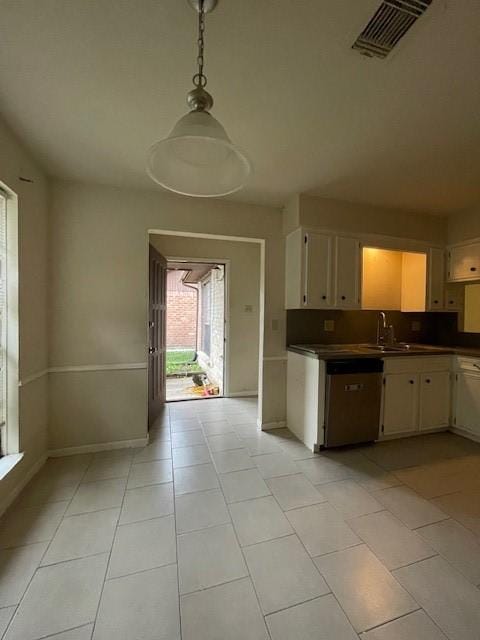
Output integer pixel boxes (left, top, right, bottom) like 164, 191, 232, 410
0, 0, 480, 213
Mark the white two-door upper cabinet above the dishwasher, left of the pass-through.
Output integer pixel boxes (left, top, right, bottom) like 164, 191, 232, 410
285, 229, 361, 309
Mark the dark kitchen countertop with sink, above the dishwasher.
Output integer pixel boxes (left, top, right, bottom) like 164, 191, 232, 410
287, 344, 480, 360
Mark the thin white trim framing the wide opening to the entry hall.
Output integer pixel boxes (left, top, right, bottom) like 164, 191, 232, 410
144, 228, 266, 426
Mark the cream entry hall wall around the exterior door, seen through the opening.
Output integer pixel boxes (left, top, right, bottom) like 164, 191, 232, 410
150, 235, 260, 394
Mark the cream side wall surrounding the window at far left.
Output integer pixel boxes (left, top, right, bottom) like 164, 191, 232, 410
0, 121, 48, 509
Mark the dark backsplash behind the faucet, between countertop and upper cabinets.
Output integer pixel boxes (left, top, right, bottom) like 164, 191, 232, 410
287, 309, 480, 347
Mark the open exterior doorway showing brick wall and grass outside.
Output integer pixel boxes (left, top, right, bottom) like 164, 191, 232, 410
166, 258, 228, 402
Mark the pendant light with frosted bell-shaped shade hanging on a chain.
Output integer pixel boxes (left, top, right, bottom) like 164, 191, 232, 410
147, 0, 251, 198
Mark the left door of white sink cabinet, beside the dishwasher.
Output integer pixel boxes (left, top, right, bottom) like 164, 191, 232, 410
382, 373, 419, 436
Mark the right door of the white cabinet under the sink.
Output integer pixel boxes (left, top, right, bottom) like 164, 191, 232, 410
419, 371, 451, 431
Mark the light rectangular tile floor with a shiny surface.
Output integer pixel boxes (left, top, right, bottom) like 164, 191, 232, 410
0, 398, 480, 640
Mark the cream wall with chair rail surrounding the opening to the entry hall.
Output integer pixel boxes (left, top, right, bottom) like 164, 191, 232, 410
49, 181, 286, 448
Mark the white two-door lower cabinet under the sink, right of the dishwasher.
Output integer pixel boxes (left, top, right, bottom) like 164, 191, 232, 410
380, 357, 452, 437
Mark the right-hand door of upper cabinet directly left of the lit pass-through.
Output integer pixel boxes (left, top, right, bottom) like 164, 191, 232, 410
334, 236, 361, 309
